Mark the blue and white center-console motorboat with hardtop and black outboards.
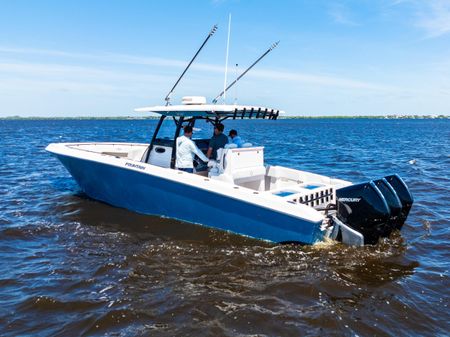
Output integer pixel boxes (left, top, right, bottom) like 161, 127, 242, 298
46, 97, 412, 245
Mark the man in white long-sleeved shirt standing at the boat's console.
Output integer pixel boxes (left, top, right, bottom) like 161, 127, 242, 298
175, 125, 208, 173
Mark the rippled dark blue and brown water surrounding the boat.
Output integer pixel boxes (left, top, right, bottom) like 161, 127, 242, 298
0, 119, 450, 336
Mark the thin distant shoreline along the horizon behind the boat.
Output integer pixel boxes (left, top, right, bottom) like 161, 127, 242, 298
0, 115, 450, 120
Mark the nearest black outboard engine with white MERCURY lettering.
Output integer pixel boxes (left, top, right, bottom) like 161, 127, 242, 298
336, 181, 392, 244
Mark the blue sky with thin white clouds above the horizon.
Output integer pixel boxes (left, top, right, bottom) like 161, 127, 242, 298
0, 0, 450, 117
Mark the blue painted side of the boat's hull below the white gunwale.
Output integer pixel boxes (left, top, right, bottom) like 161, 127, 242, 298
57, 155, 322, 244
